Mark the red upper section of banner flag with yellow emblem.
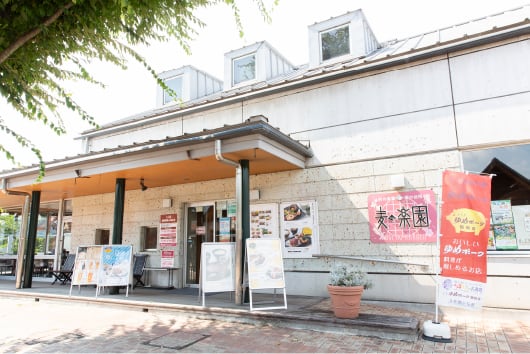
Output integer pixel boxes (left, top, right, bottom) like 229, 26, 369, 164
440, 171, 491, 283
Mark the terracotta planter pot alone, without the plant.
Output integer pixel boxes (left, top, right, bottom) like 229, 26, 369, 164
328, 285, 364, 318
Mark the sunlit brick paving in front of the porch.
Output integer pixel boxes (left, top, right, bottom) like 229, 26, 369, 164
0, 297, 530, 353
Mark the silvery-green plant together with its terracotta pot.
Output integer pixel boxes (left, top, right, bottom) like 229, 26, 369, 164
328, 263, 372, 318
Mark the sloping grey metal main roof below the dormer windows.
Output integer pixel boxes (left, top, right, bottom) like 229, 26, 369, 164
83, 4, 530, 136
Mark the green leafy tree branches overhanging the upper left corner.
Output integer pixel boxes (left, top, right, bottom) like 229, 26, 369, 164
0, 0, 269, 177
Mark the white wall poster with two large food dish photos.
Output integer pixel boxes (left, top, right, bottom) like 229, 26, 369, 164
280, 200, 320, 258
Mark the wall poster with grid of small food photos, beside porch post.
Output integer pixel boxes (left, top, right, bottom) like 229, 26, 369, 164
250, 204, 278, 238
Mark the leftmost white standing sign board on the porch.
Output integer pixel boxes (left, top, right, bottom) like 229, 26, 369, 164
70, 246, 101, 295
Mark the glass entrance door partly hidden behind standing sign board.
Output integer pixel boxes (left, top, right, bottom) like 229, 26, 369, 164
186, 203, 215, 286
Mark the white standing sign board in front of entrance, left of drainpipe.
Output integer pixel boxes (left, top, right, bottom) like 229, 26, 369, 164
199, 242, 235, 306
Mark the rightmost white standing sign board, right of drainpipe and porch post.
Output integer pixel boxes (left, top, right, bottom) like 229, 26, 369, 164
246, 238, 287, 311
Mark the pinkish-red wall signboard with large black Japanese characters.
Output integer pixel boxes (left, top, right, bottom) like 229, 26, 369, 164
368, 190, 437, 243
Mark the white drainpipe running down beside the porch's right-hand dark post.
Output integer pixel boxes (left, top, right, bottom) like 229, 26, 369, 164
215, 140, 244, 305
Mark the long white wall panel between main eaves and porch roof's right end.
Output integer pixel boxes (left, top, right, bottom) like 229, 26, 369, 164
244, 61, 451, 134
